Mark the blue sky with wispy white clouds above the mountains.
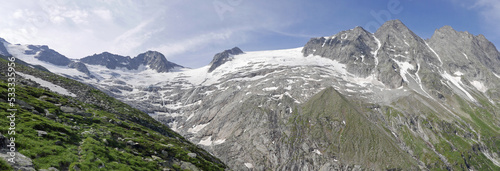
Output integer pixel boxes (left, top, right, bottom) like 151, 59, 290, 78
0, 0, 500, 68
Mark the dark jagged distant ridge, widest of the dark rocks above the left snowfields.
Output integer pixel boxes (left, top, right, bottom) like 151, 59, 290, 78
80, 51, 183, 72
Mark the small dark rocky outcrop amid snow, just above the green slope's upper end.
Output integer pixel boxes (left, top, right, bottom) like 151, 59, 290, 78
24, 45, 71, 66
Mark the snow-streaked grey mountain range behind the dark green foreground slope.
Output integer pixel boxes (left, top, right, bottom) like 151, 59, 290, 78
0, 20, 500, 170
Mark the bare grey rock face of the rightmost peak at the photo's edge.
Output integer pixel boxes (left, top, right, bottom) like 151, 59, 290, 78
429, 26, 500, 97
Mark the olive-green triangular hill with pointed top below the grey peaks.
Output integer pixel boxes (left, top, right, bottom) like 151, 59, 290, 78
290, 87, 417, 170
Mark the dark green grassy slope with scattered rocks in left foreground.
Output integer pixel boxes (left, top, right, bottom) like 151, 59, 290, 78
0, 56, 226, 170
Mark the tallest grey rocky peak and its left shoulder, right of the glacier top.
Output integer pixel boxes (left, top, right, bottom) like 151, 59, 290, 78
302, 20, 448, 88
